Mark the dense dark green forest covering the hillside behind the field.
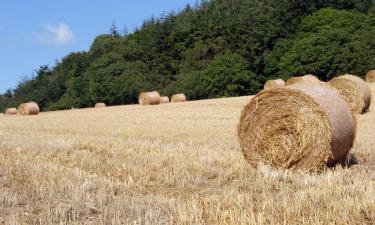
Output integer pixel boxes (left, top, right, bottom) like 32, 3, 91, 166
0, 0, 375, 111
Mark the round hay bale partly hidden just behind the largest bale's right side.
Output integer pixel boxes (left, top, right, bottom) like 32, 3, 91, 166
328, 74, 371, 113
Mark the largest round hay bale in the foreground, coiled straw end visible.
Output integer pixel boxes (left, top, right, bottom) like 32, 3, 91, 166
238, 84, 355, 172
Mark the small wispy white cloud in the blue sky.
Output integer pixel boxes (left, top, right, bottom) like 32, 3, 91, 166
37, 23, 74, 46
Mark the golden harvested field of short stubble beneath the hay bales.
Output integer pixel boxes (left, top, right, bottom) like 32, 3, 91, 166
0, 86, 375, 225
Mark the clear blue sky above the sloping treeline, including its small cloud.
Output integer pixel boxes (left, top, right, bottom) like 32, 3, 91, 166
0, 0, 197, 93
